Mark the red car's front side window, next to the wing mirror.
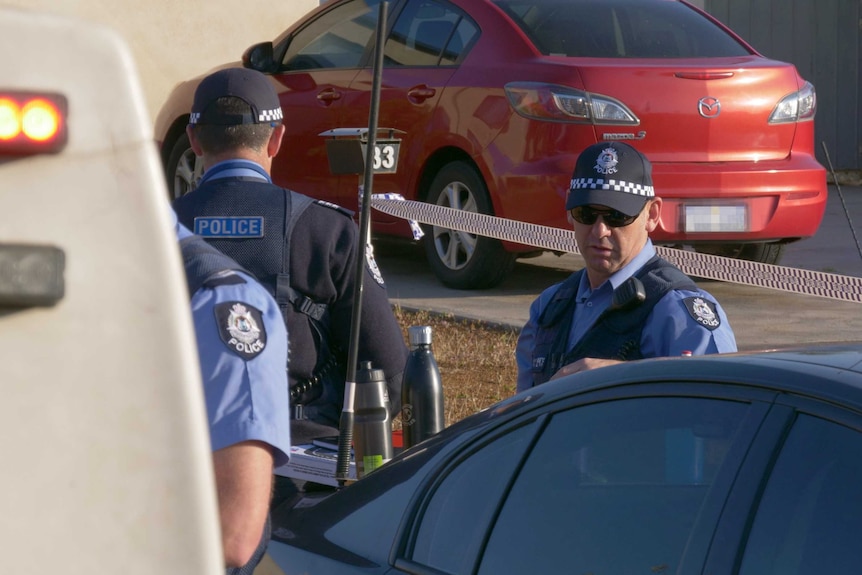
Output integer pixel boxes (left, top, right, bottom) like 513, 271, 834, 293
282, 0, 379, 71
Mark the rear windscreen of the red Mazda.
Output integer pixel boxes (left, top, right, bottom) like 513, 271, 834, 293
495, 0, 750, 58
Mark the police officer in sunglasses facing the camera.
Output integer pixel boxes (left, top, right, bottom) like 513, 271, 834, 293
515, 142, 736, 391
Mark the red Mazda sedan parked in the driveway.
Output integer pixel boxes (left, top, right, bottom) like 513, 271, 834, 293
156, 0, 827, 288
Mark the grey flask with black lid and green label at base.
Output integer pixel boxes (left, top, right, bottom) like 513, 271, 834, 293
353, 361, 392, 479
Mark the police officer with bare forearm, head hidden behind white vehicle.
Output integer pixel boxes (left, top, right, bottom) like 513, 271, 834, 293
176, 213, 290, 575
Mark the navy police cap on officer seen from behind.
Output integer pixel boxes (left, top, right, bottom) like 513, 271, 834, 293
189, 68, 282, 126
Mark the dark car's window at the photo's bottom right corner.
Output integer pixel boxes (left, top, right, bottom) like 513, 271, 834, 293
739, 415, 862, 575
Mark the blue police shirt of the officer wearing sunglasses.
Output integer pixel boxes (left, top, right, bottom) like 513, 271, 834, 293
515, 239, 736, 391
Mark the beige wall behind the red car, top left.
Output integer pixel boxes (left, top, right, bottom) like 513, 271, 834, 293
0, 0, 320, 125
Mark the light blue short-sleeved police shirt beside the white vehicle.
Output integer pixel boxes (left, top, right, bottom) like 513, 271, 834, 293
177, 216, 290, 466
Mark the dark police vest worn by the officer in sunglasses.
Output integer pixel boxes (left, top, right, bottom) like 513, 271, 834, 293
531, 256, 697, 386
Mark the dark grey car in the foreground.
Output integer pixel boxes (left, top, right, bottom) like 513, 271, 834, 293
269, 345, 862, 575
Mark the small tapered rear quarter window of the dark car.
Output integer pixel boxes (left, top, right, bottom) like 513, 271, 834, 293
412, 422, 537, 573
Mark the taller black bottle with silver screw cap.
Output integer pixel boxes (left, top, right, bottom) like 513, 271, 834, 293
401, 325, 444, 449
